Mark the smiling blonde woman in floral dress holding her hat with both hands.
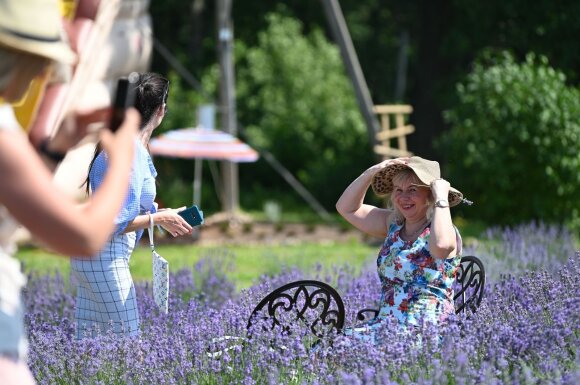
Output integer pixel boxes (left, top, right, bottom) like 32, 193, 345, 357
336, 156, 463, 342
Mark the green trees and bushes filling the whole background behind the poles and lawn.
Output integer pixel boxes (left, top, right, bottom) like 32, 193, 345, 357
146, 0, 580, 229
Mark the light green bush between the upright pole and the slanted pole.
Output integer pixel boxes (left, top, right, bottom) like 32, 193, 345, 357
237, 14, 372, 206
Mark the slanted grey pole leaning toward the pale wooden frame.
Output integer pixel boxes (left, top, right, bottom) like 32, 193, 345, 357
321, 0, 380, 148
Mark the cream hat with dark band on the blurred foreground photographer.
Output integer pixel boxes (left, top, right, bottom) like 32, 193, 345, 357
0, 0, 76, 63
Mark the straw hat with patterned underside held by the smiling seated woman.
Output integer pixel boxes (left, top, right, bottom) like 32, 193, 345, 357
371, 156, 463, 206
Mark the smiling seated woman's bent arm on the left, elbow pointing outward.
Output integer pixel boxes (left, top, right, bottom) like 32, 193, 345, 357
336, 158, 404, 237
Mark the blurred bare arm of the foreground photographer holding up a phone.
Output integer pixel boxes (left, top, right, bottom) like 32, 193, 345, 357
0, 109, 140, 255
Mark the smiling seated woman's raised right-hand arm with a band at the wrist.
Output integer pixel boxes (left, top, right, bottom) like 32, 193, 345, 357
429, 179, 457, 259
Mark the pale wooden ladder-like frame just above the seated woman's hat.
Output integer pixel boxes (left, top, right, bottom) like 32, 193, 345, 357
373, 104, 415, 159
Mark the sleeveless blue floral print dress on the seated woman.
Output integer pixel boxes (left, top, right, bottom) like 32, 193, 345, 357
346, 220, 461, 342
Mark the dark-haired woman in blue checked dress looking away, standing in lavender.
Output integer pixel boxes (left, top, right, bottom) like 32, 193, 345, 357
71, 73, 192, 339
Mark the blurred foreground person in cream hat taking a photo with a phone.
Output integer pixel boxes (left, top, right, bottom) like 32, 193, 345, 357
0, 0, 139, 385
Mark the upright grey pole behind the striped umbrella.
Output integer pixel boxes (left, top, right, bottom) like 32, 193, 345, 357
217, 0, 239, 214
